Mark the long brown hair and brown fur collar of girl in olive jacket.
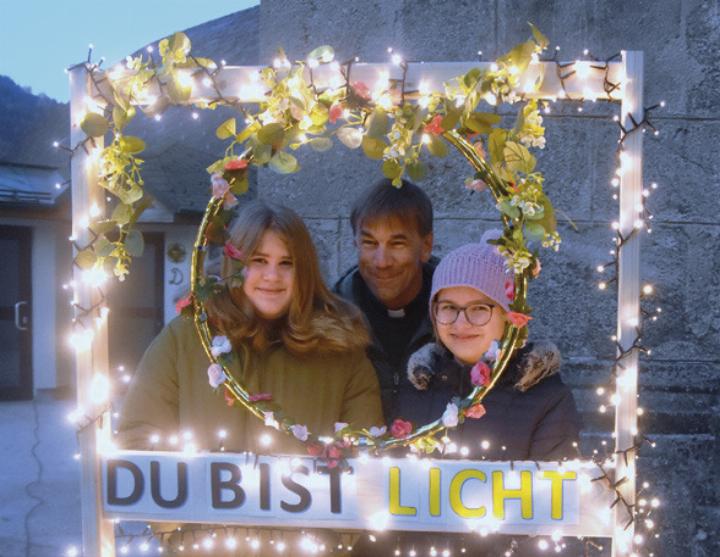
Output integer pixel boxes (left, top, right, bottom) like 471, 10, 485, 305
206, 201, 369, 355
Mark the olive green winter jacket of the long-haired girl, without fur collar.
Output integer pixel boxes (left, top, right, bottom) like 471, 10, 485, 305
117, 317, 383, 454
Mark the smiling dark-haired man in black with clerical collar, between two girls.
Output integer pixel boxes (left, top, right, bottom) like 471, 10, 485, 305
334, 179, 437, 423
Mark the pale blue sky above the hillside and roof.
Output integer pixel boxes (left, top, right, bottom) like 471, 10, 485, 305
0, 0, 260, 102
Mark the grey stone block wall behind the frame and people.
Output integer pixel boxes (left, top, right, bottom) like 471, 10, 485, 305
258, 0, 720, 557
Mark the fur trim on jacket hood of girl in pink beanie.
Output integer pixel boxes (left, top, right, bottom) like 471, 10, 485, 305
407, 340, 561, 392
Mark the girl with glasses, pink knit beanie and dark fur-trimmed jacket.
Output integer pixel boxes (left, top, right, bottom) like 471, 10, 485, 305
399, 231, 581, 460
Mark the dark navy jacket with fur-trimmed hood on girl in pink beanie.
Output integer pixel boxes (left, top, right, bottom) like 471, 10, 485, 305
398, 342, 581, 460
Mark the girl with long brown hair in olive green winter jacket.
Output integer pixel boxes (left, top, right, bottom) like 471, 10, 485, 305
118, 201, 383, 453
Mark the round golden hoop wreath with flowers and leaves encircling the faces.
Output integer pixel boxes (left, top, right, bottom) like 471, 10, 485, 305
173, 27, 560, 466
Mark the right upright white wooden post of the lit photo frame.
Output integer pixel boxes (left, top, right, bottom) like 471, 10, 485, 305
612, 51, 644, 557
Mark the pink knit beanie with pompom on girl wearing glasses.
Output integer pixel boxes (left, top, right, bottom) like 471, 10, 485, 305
430, 230, 513, 311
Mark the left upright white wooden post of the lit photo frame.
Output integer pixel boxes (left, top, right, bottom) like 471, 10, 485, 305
69, 65, 115, 557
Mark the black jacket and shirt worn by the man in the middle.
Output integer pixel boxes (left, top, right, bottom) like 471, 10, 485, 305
333, 258, 438, 424
